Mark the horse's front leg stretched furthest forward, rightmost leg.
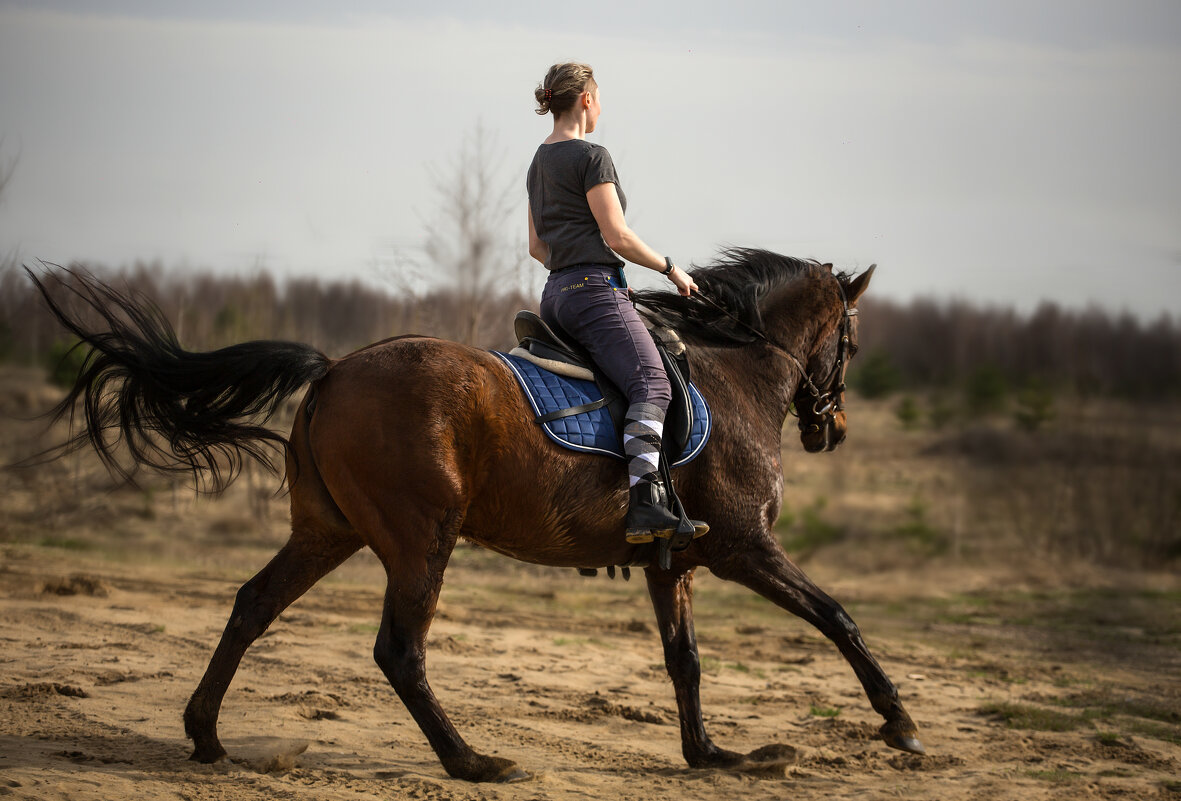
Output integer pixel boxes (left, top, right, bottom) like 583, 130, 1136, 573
710, 543, 926, 754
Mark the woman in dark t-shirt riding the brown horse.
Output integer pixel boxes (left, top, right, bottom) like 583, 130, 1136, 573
527, 64, 706, 542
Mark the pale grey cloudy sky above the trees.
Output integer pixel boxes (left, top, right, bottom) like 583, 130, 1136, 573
0, 0, 1181, 319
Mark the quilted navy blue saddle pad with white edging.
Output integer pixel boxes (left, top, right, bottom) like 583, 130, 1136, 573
492, 351, 711, 467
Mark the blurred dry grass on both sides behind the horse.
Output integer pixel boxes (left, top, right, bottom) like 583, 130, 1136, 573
0, 367, 1181, 573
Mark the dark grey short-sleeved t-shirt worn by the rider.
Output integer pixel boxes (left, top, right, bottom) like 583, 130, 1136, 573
526, 139, 627, 271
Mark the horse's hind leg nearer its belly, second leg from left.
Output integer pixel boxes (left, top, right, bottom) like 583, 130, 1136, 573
373, 512, 528, 781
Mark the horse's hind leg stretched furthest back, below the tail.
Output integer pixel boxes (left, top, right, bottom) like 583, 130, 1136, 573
184, 525, 361, 762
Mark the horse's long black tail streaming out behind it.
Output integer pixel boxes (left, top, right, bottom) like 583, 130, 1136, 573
25, 268, 331, 493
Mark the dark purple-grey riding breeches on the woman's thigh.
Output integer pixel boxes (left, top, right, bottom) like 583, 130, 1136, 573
541, 265, 672, 411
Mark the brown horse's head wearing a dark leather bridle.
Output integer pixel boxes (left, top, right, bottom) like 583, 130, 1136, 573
792, 265, 874, 454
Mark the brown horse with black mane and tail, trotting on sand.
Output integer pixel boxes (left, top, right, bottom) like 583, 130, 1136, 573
30, 248, 925, 782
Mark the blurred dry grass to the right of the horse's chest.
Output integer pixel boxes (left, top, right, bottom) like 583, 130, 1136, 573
779, 389, 1181, 569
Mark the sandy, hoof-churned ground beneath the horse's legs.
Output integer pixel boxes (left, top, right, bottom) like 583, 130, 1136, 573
0, 545, 1181, 801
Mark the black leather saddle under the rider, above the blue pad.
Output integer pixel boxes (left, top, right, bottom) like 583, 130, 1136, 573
509, 311, 707, 464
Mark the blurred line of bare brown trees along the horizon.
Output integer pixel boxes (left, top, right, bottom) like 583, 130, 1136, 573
0, 263, 1181, 401
